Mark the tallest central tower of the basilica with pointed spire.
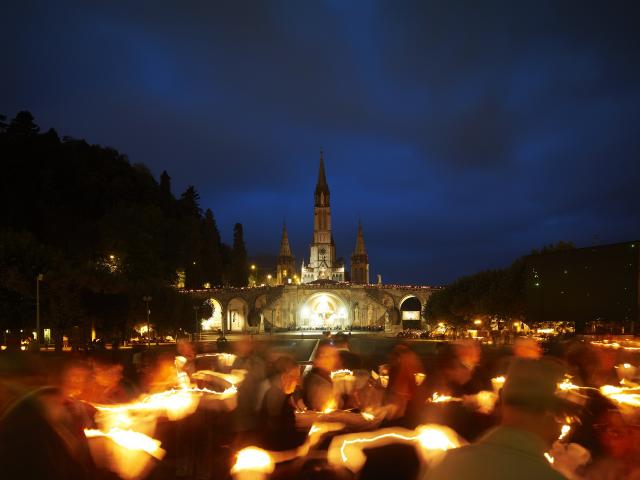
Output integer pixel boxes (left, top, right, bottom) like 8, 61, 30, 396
302, 150, 344, 283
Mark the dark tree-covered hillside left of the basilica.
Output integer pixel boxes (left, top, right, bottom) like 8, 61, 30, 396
0, 111, 249, 341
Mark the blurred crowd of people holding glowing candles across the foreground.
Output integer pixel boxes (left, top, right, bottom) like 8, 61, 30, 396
0, 334, 640, 480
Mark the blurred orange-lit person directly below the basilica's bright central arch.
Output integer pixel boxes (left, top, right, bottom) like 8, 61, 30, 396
303, 340, 340, 411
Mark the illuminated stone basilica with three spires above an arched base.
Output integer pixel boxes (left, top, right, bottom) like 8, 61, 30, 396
185, 152, 433, 334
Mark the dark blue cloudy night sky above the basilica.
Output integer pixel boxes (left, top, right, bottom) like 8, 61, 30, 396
0, 0, 640, 285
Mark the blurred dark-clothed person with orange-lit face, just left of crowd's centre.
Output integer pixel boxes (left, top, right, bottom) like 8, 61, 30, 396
261, 355, 306, 450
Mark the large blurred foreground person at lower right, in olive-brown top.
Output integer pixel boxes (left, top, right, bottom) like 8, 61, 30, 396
425, 359, 571, 480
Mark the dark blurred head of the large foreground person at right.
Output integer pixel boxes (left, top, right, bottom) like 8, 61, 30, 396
501, 359, 572, 445
